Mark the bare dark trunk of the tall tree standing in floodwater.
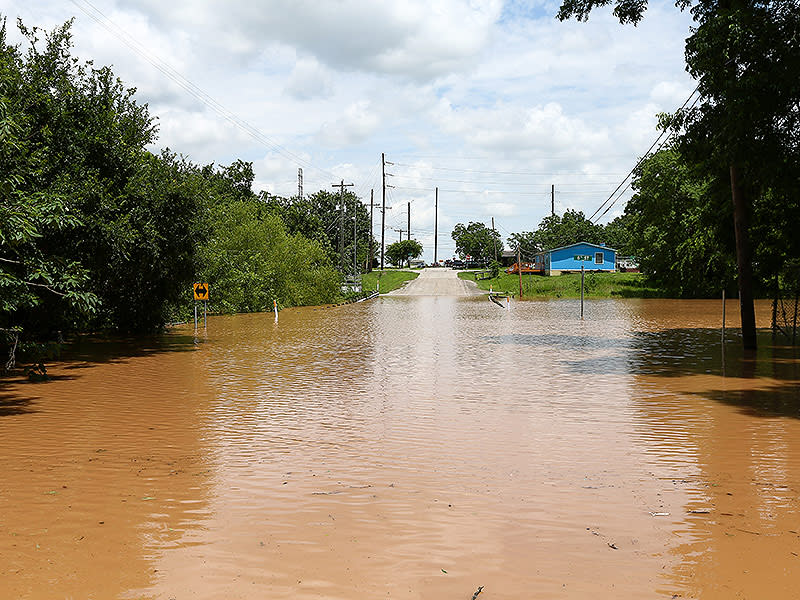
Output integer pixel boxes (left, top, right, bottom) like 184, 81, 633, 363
730, 165, 757, 350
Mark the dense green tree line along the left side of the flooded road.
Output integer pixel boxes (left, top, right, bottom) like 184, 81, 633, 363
0, 20, 371, 366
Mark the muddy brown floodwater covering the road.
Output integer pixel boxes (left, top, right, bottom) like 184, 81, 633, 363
0, 297, 800, 600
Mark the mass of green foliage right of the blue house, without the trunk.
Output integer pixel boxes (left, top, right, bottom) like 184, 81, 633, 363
558, 0, 800, 310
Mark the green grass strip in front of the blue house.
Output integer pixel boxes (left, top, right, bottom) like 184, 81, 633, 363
458, 271, 664, 298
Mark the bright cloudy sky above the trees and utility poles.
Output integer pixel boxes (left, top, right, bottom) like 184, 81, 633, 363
0, 0, 695, 261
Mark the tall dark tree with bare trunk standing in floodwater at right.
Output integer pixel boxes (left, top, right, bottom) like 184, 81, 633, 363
558, 0, 800, 349
